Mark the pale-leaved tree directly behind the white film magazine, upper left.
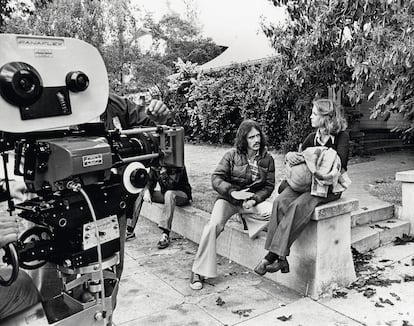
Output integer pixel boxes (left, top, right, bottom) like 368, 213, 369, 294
5, 0, 141, 94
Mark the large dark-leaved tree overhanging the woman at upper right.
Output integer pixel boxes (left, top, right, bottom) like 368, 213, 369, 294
264, 0, 414, 138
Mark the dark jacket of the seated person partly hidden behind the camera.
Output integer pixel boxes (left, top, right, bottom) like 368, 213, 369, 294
147, 167, 192, 200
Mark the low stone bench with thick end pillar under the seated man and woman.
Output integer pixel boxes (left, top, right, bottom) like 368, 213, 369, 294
141, 198, 358, 299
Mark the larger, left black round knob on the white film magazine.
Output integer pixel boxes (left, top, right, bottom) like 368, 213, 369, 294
0, 62, 43, 106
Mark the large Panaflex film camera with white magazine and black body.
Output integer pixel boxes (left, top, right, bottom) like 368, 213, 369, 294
0, 34, 184, 325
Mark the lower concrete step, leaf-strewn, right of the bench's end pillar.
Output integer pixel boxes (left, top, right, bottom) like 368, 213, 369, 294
351, 218, 410, 253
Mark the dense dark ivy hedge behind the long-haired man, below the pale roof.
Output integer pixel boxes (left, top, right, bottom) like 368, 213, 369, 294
168, 59, 309, 149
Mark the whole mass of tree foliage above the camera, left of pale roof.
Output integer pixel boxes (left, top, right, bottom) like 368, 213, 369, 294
0, 0, 222, 95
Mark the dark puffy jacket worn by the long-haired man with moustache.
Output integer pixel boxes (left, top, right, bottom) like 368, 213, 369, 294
211, 148, 275, 205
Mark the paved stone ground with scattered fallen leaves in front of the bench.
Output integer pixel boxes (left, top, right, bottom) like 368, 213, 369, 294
114, 218, 414, 326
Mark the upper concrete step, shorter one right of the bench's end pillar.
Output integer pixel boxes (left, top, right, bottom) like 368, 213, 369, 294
351, 202, 394, 227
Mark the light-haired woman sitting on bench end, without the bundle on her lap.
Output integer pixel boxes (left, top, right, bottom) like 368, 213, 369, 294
255, 99, 349, 275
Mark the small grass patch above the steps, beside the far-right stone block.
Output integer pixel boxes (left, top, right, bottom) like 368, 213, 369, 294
368, 177, 402, 206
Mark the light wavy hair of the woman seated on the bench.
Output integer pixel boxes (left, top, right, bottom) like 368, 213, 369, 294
313, 99, 348, 135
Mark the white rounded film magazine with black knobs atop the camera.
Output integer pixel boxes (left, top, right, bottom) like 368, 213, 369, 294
0, 34, 109, 132
